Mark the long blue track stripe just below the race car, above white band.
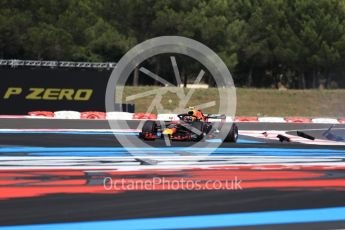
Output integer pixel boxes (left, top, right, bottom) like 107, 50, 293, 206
0, 147, 345, 157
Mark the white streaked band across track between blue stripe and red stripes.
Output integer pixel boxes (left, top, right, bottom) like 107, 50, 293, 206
0, 156, 345, 170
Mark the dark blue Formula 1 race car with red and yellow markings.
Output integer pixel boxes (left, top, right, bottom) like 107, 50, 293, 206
139, 110, 238, 143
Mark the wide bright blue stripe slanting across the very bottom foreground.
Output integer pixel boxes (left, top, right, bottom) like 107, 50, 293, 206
0, 207, 345, 230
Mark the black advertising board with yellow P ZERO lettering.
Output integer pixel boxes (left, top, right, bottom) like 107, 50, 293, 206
0, 68, 111, 114
